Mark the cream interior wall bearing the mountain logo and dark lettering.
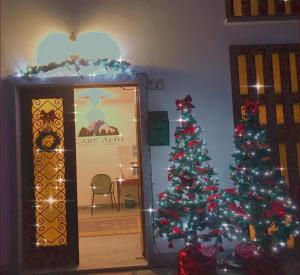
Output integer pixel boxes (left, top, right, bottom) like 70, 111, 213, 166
74, 87, 137, 206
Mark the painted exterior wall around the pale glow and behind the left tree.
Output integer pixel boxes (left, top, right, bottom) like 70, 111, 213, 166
1, 0, 300, 268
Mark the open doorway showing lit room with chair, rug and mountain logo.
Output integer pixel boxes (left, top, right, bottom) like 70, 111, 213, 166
74, 86, 147, 268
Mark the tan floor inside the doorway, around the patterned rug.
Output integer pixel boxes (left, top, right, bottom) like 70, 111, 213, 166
78, 206, 147, 270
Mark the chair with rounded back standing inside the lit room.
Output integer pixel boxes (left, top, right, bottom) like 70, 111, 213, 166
91, 174, 118, 215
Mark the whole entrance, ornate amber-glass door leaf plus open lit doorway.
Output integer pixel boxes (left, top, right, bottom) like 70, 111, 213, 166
18, 80, 148, 270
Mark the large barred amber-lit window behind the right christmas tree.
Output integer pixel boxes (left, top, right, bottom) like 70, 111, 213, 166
230, 44, 300, 204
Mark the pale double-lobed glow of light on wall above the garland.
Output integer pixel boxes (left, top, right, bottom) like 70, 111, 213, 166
36, 32, 121, 65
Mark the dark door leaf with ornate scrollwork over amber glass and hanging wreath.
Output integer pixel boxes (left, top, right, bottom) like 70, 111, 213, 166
18, 86, 79, 268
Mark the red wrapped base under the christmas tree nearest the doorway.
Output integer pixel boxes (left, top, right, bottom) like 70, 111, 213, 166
177, 245, 218, 275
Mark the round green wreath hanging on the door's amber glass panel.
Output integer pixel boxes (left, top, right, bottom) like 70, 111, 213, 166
35, 130, 61, 152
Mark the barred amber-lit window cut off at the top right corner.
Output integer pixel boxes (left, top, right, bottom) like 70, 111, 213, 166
226, 0, 300, 21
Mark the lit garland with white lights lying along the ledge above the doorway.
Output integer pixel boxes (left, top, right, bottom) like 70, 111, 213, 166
16, 56, 133, 78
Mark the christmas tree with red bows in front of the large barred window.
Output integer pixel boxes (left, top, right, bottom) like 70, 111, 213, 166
230, 100, 299, 254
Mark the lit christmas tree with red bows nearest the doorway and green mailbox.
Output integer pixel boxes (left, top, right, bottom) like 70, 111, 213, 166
155, 96, 223, 248
